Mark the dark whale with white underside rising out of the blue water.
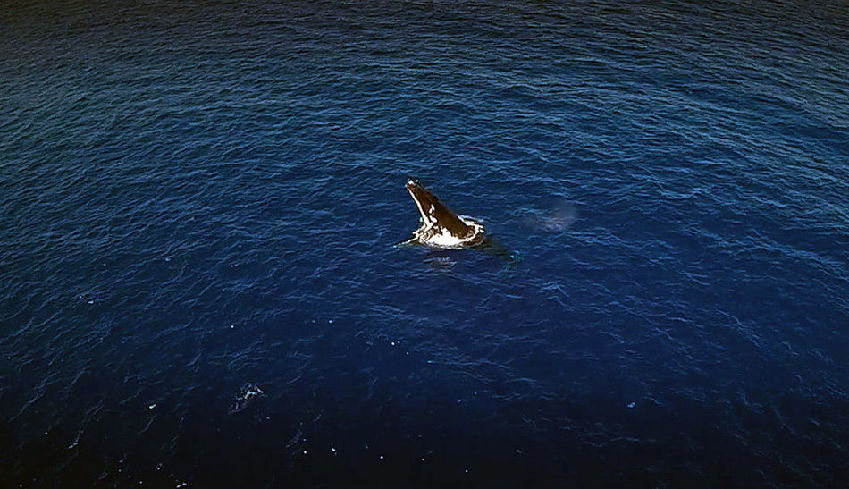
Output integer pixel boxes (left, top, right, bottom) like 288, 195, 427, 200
407, 178, 485, 248
